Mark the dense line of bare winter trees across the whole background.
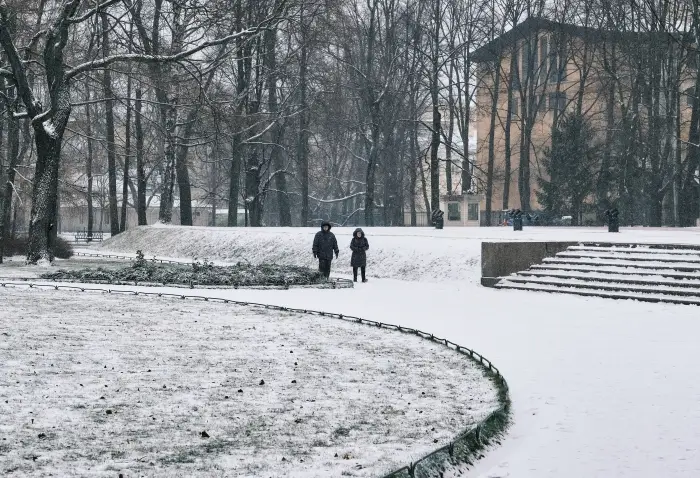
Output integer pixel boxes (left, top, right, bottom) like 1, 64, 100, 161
0, 0, 700, 262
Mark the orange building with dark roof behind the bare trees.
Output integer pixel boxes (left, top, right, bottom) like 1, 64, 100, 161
474, 18, 696, 224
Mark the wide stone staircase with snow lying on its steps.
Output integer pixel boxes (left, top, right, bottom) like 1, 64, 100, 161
495, 242, 700, 305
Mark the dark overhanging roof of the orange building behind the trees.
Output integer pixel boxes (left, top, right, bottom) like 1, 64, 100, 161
471, 17, 682, 63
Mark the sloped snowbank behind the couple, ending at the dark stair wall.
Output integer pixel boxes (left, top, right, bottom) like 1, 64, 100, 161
99, 226, 481, 281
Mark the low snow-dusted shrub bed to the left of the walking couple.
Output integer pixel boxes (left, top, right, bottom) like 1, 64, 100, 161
41, 251, 324, 287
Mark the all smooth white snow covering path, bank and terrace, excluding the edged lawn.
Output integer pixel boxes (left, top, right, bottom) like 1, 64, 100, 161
0, 227, 700, 478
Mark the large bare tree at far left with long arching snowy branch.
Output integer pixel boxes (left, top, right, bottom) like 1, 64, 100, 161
0, 0, 279, 263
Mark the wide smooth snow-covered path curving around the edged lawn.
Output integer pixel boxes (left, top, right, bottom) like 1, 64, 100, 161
12, 280, 700, 478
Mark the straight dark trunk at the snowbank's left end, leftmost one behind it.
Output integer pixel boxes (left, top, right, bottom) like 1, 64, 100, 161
100, 12, 119, 236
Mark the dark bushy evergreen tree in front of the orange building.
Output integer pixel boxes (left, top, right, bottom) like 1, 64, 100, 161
537, 114, 600, 225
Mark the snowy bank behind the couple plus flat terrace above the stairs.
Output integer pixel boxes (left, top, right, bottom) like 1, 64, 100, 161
94, 226, 700, 282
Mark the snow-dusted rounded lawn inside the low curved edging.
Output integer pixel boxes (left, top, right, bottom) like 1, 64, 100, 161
0, 286, 497, 477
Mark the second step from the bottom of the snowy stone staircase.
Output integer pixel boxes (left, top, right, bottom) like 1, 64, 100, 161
507, 276, 700, 300
